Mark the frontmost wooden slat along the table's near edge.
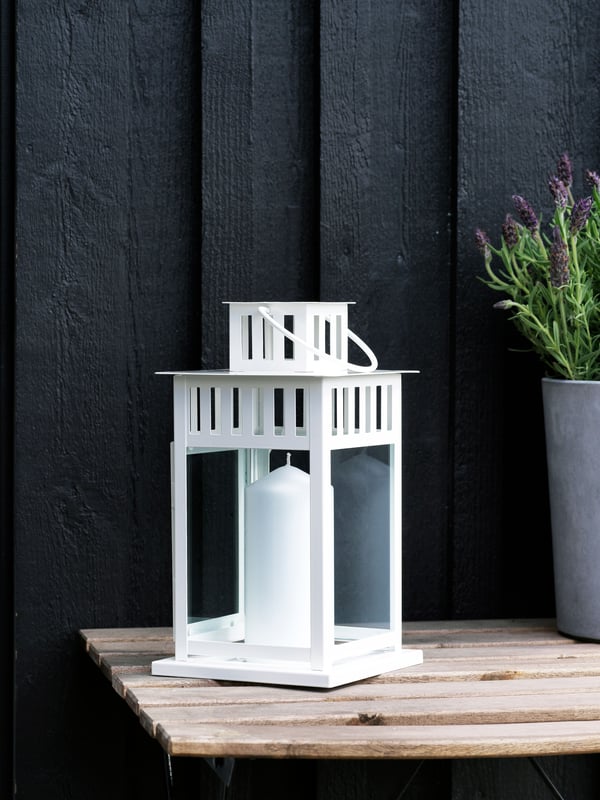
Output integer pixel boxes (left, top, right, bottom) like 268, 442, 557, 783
156, 721, 600, 759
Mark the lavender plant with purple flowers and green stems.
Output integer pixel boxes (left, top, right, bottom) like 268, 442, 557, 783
475, 153, 600, 380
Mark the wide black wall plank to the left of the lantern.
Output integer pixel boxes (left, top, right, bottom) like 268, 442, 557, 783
14, 0, 199, 800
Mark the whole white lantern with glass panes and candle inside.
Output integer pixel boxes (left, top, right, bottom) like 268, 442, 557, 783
152, 303, 422, 687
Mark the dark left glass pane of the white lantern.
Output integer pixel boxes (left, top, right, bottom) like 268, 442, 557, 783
188, 450, 239, 622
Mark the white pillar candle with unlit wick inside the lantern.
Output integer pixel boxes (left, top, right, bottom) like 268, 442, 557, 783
245, 453, 310, 647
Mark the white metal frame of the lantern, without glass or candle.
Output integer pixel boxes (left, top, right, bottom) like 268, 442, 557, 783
152, 303, 422, 688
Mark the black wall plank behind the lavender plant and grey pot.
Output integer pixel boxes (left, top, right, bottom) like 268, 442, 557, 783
453, 0, 600, 616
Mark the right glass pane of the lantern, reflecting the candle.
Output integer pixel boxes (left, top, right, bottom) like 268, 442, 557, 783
331, 445, 391, 629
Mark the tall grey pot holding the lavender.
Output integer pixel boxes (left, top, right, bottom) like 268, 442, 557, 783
542, 378, 600, 641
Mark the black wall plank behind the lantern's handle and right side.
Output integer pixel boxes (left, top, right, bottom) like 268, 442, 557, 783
320, 0, 454, 618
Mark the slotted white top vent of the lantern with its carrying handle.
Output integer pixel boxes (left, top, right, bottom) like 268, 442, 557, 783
227, 302, 377, 375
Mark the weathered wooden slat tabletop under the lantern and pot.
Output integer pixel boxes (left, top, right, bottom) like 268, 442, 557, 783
81, 620, 600, 759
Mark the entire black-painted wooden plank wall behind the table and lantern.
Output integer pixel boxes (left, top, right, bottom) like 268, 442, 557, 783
0, 0, 600, 800
